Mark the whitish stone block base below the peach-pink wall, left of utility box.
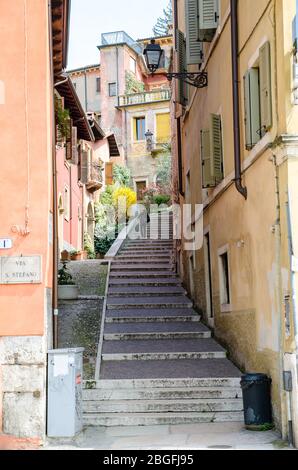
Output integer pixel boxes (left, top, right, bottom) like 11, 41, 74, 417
0, 336, 46, 439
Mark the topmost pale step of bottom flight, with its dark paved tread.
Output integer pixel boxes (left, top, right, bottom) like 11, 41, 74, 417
84, 374, 241, 393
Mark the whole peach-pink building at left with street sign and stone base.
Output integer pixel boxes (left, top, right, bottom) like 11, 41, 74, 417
0, 0, 70, 448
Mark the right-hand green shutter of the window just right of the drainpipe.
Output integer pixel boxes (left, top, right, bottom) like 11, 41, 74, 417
260, 41, 272, 131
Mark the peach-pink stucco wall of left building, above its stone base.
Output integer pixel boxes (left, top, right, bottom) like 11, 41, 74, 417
0, 1, 52, 336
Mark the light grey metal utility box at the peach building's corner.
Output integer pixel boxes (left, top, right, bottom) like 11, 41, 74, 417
47, 348, 84, 437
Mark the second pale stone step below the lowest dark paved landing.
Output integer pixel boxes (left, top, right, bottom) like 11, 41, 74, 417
83, 386, 242, 401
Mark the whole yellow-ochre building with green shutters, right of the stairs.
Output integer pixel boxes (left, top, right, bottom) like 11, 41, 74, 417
172, 0, 298, 445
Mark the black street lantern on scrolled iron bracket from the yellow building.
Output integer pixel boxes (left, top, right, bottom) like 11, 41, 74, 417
144, 39, 208, 88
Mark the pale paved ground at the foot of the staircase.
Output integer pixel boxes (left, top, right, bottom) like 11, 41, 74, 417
46, 423, 289, 450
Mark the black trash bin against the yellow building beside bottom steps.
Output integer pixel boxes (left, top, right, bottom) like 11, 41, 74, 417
241, 374, 273, 430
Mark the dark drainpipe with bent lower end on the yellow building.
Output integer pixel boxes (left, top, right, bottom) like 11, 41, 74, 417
231, 0, 247, 199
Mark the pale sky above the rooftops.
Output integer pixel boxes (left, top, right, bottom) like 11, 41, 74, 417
67, 0, 168, 70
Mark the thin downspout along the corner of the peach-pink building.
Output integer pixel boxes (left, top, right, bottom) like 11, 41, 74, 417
48, 0, 59, 349
